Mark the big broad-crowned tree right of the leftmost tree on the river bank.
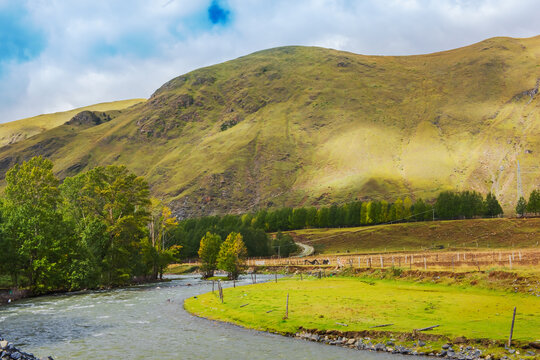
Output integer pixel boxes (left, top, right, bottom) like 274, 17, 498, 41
64, 166, 153, 285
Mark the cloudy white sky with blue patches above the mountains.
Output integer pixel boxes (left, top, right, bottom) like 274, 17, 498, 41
0, 0, 540, 122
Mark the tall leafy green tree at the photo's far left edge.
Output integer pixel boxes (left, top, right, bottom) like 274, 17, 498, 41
2, 157, 76, 293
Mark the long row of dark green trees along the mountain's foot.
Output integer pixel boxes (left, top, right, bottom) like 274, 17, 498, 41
168, 191, 503, 258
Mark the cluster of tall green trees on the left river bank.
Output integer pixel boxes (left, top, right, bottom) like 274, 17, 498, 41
0, 157, 180, 293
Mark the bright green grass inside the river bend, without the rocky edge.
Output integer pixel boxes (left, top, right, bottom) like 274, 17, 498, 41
184, 277, 540, 341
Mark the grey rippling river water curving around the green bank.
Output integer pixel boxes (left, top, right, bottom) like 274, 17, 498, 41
0, 276, 402, 360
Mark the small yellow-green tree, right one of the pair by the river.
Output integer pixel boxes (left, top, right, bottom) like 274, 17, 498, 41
217, 232, 247, 280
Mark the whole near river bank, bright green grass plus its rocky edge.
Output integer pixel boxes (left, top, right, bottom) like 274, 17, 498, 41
184, 277, 540, 359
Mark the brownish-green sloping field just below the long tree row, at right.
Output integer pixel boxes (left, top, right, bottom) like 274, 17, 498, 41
292, 218, 540, 254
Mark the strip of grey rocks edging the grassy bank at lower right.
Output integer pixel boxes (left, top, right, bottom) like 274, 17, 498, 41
293, 330, 538, 360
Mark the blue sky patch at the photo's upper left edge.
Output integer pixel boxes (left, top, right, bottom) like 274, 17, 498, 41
0, 4, 46, 63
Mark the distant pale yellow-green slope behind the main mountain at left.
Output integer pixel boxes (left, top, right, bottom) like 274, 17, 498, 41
0, 99, 146, 146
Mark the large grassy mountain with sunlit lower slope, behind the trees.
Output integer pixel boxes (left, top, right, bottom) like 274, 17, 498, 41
0, 36, 540, 216
